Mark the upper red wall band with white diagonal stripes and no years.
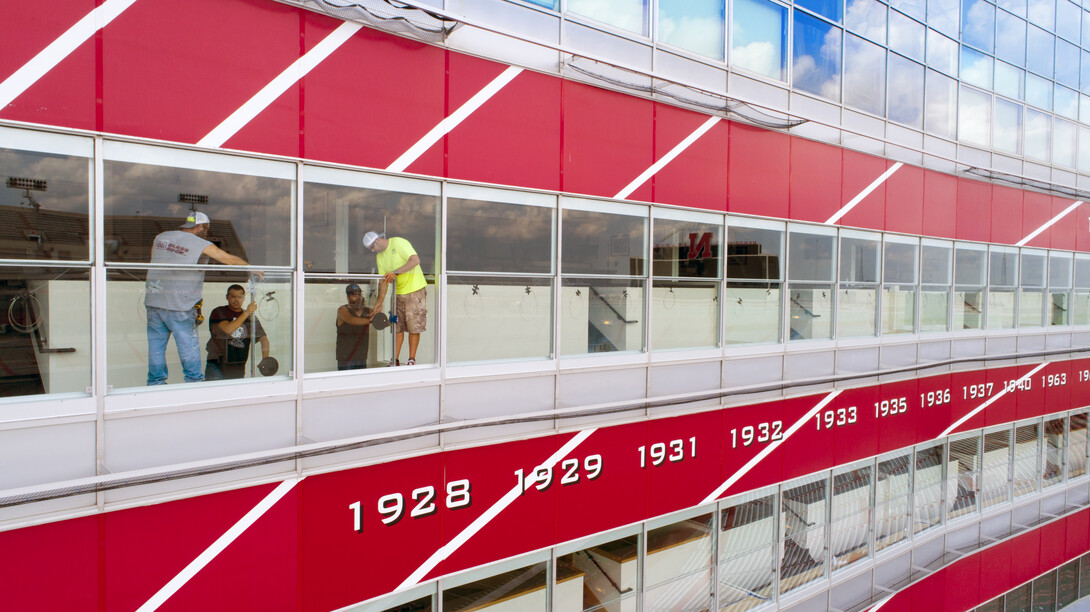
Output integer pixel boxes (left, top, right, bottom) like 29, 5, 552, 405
0, 0, 1090, 251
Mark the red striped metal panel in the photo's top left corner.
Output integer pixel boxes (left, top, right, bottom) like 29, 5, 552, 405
0, 0, 97, 130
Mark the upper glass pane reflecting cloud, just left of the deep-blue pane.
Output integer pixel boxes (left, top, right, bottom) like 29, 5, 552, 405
730, 0, 787, 81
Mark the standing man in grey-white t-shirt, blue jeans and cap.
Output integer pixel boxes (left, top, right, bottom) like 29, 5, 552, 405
144, 213, 247, 385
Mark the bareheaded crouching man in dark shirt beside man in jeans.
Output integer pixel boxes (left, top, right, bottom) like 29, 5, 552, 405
205, 285, 269, 381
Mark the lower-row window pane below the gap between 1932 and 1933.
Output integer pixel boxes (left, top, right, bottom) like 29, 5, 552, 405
779, 476, 828, 592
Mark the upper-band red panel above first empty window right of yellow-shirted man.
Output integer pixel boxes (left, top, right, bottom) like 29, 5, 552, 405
447, 62, 560, 190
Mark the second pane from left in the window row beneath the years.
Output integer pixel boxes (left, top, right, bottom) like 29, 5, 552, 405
443, 562, 545, 612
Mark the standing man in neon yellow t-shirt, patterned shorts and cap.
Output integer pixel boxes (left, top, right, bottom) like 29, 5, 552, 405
363, 231, 427, 365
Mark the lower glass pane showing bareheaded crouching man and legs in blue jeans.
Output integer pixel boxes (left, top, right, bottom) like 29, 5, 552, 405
106, 266, 293, 388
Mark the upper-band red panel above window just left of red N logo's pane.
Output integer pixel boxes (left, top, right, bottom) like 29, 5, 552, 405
560, 81, 654, 199
